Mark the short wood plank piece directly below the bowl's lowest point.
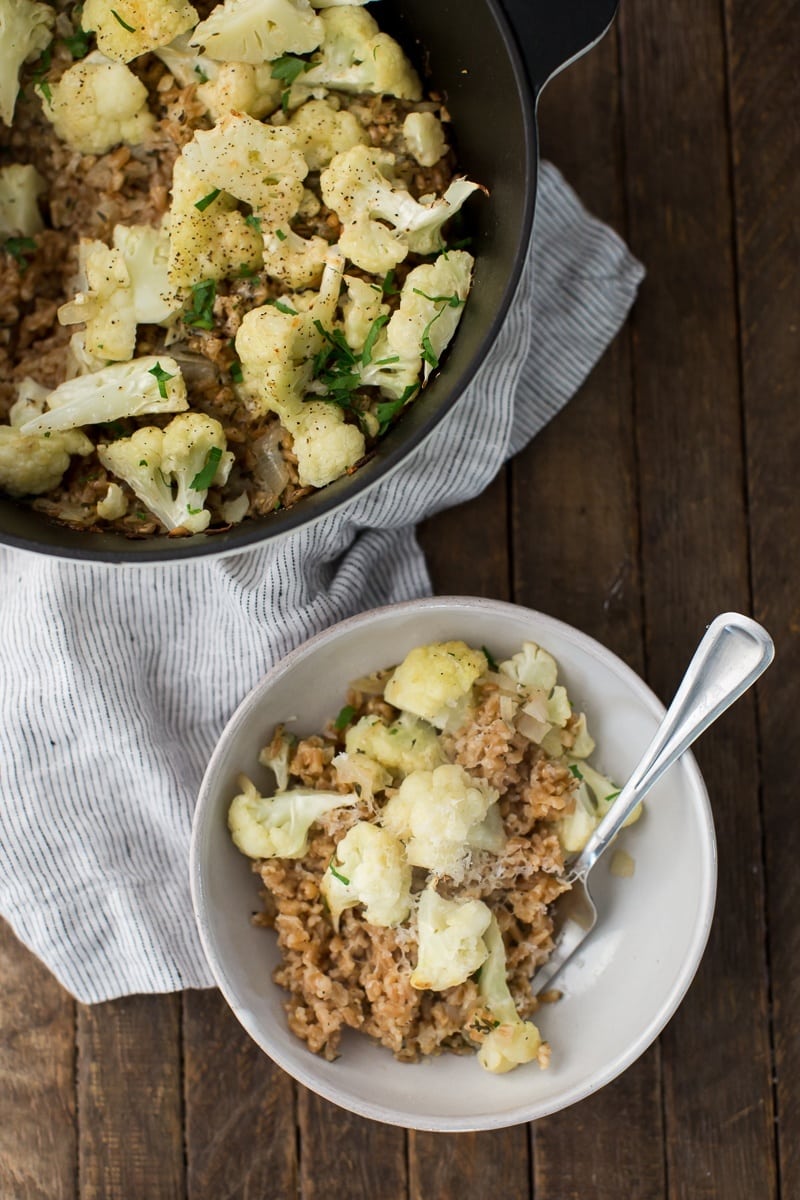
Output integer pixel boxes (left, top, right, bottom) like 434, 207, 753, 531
409, 1126, 530, 1200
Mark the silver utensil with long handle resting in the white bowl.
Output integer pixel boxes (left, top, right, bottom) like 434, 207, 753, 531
531, 612, 775, 995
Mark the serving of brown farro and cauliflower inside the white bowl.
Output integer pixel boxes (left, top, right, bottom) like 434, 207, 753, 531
228, 641, 638, 1073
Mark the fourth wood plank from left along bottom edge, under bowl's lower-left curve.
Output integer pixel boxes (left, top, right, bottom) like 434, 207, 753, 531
297, 1086, 408, 1200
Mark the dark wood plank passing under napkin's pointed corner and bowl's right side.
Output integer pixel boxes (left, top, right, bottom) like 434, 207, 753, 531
512, 21, 664, 1200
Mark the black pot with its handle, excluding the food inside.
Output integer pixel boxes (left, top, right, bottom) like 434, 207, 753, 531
0, 0, 618, 563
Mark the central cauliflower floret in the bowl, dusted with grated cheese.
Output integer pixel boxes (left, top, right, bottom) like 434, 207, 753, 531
381, 763, 498, 877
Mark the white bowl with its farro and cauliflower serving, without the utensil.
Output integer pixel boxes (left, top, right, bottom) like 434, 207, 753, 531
191, 598, 716, 1130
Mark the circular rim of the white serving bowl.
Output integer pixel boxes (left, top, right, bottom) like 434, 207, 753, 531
190, 595, 717, 1133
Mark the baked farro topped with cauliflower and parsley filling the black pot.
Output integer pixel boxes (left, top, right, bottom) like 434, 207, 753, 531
0, 0, 479, 536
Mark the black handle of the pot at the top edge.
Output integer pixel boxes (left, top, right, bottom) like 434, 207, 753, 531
503, 0, 619, 97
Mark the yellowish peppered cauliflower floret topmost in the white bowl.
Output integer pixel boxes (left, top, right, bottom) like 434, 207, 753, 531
384, 642, 487, 728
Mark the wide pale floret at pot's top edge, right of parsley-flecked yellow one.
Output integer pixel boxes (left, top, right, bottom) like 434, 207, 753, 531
192, 0, 324, 64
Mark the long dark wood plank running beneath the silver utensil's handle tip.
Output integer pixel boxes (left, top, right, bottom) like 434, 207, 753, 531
620, 0, 776, 1200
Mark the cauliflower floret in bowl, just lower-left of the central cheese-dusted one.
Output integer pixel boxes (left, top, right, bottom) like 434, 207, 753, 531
319, 821, 411, 929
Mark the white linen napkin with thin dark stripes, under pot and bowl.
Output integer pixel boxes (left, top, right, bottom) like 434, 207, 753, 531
0, 163, 643, 1003
